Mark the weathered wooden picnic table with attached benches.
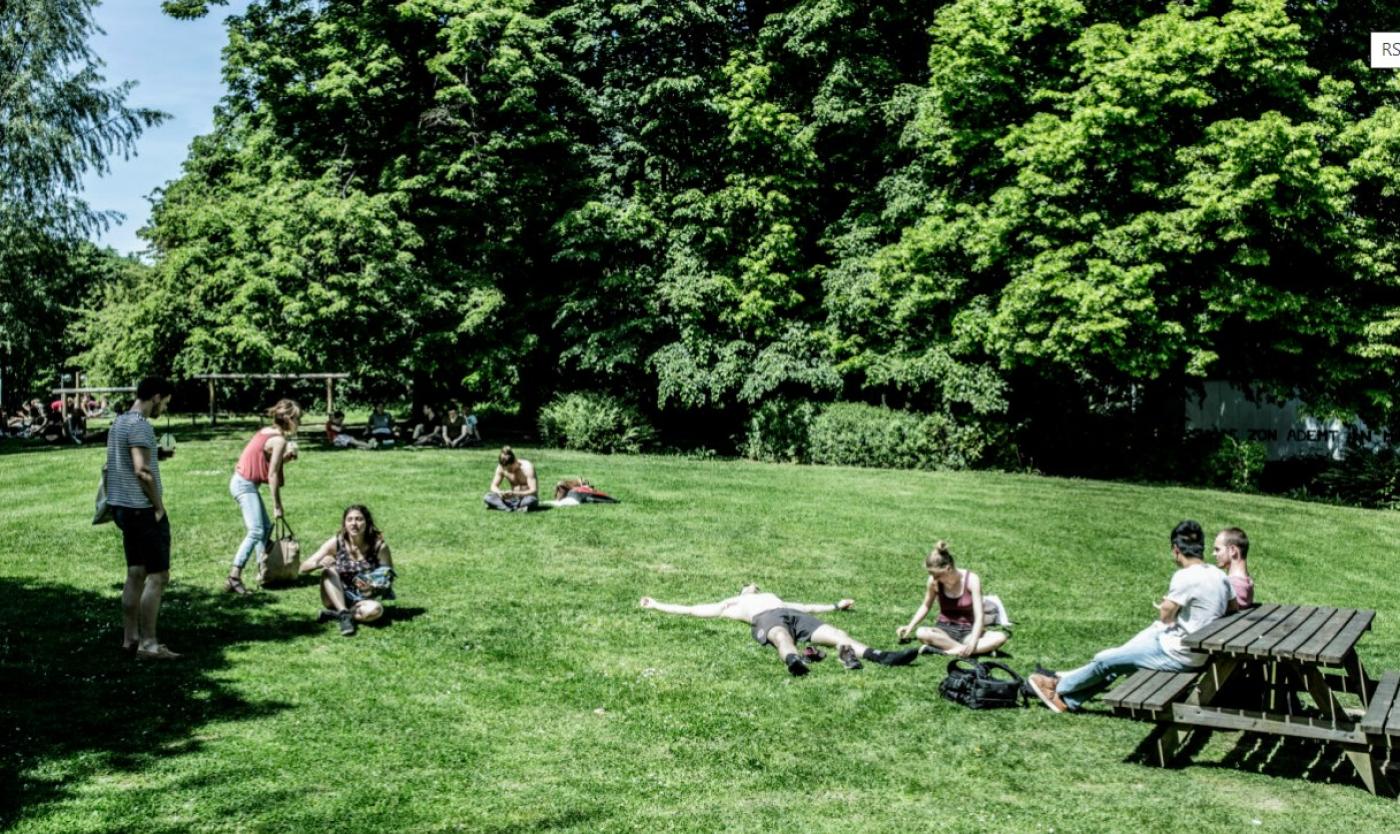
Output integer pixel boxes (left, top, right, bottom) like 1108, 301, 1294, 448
1112, 605, 1400, 796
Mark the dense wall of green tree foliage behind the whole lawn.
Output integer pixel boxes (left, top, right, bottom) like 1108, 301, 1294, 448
57, 0, 1400, 465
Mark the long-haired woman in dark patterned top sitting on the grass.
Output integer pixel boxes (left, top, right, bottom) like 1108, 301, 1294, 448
301, 504, 393, 637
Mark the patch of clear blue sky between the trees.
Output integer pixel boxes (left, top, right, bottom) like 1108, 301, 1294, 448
83, 0, 248, 255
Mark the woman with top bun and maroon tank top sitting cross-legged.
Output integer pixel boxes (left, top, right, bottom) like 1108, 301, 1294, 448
895, 542, 1011, 658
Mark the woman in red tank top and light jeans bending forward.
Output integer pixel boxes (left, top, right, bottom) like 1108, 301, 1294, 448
224, 399, 301, 595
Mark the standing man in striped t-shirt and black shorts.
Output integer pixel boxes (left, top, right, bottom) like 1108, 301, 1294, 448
106, 376, 179, 660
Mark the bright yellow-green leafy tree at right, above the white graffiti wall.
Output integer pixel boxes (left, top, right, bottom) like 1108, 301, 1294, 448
841, 0, 1400, 439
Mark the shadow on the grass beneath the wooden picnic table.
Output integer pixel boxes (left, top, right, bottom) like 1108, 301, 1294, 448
1127, 729, 1366, 791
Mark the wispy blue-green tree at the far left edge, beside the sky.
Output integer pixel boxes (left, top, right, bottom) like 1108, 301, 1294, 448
0, 0, 164, 388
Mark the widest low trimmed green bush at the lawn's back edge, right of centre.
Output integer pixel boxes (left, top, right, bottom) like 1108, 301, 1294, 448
808, 403, 986, 469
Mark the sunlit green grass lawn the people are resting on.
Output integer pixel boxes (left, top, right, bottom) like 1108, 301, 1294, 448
0, 425, 1400, 834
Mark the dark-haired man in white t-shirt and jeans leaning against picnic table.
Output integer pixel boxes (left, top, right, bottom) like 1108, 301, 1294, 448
1029, 521, 1233, 712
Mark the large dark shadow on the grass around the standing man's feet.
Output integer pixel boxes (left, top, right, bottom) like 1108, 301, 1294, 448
0, 578, 318, 830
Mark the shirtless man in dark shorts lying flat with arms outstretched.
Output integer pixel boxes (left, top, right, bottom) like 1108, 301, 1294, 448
640, 585, 918, 676
